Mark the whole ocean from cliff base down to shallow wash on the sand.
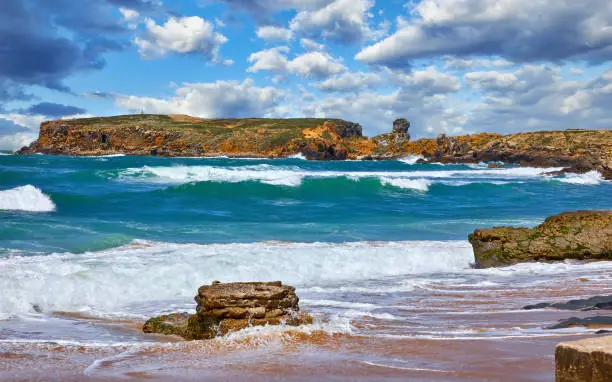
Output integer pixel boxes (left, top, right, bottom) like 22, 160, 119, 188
0, 155, 612, 381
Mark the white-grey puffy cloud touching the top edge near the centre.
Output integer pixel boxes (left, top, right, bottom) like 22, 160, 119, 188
290, 0, 374, 43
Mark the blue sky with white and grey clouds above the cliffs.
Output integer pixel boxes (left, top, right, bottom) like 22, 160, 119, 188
0, 0, 612, 150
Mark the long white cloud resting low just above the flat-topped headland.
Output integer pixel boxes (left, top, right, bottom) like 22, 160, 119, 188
115, 79, 285, 118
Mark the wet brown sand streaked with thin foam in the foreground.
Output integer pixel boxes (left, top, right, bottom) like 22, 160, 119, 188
0, 268, 612, 382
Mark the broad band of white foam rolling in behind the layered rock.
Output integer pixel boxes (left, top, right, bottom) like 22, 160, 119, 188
0, 241, 473, 317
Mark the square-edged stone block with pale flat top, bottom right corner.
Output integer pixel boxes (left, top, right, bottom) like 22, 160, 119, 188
555, 336, 612, 382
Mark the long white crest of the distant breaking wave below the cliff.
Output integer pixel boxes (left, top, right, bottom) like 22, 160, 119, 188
118, 164, 560, 191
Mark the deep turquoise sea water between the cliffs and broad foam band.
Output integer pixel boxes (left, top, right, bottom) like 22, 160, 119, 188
0, 155, 612, 257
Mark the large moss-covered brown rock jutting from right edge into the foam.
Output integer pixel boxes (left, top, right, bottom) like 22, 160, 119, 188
469, 210, 612, 268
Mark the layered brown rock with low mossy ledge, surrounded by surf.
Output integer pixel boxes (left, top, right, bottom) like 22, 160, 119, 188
143, 281, 312, 340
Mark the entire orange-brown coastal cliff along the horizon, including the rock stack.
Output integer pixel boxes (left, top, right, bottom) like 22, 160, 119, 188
18, 115, 612, 179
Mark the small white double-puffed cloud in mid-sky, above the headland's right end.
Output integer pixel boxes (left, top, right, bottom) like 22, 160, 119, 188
247, 46, 346, 78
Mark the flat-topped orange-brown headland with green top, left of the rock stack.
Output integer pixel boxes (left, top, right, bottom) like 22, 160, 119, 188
19, 115, 366, 160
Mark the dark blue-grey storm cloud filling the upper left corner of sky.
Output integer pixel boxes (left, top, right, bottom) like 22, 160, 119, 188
0, 0, 139, 101
